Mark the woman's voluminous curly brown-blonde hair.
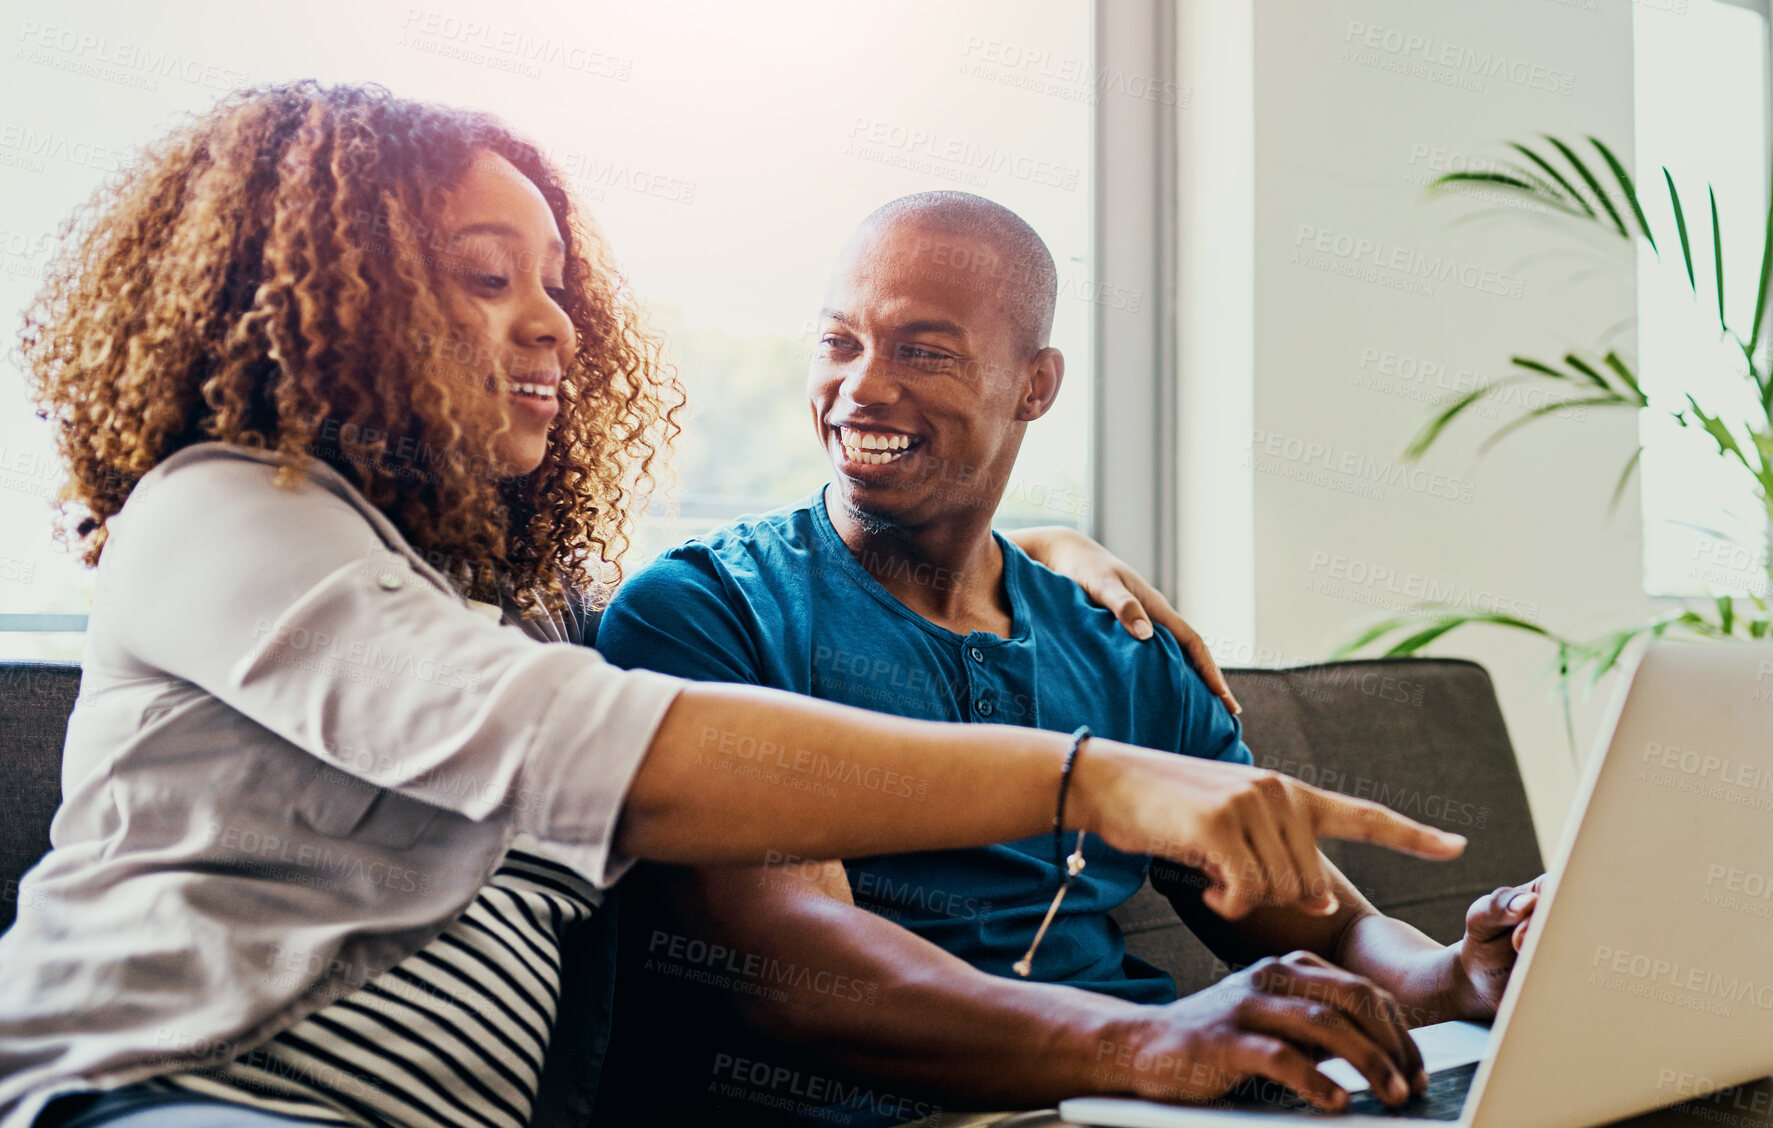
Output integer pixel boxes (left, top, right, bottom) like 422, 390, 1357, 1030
20, 82, 684, 612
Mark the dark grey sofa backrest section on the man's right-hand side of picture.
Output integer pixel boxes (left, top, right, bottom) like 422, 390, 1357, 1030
1115, 658, 1543, 995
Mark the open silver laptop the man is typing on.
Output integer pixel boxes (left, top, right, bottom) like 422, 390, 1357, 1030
1058, 642, 1773, 1128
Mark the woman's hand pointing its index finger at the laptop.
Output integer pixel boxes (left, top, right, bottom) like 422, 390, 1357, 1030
1071, 740, 1464, 920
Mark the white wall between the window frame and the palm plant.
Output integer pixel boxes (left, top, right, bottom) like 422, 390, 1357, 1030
1177, 0, 1649, 851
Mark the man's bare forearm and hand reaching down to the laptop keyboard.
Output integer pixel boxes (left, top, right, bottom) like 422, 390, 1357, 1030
663, 862, 1420, 1108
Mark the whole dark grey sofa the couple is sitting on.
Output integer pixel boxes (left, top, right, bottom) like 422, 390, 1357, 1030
0, 658, 1541, 971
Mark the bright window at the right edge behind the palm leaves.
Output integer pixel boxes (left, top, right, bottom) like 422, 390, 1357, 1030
1633, 0, 1769, 596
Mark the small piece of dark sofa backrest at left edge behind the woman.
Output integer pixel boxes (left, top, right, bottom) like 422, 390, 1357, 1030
0, 662, 80, 933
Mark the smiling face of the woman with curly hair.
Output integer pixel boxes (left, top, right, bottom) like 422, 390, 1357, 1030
441, 151, 576, 475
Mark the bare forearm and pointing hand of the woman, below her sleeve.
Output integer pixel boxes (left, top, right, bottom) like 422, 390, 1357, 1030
617, 683, 1464, 897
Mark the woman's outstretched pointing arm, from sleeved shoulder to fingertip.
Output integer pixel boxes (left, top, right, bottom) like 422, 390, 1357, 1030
110, 449, 1463, 897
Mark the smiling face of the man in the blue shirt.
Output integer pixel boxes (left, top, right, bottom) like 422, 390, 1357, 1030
807, 222, 1062, 525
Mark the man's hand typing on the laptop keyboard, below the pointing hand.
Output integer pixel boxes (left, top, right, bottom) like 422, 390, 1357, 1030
1096, 952, 1427, 1110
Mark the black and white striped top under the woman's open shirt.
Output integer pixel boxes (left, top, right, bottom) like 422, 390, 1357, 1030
149, 835, 603, 1128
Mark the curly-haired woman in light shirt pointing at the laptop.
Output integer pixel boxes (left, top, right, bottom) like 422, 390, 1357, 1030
0, 83, 1438, 1128
